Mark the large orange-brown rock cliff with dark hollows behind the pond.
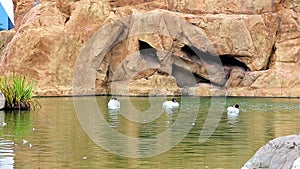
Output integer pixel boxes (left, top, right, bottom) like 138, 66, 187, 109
0, 0, 300, 97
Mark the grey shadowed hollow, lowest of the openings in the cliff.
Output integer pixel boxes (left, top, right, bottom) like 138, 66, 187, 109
172, 64, 210, 88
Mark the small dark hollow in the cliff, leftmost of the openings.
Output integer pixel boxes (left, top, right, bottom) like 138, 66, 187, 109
139, 40, 160, 65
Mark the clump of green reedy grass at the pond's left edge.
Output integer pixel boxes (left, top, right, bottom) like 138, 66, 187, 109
0, 74, 36, 110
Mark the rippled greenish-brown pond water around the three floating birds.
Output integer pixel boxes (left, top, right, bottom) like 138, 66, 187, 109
0, 97, 300, 169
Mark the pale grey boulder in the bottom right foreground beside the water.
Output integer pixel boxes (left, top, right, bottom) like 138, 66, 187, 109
243, 135, 300, 169
